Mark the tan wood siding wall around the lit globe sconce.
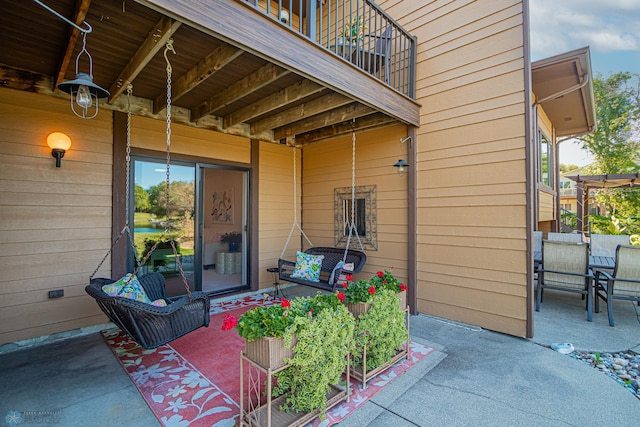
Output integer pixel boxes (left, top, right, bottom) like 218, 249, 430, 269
0, 89, 112, 344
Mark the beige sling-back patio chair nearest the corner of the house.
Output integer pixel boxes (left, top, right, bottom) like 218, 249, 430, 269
536, 240, 593, 322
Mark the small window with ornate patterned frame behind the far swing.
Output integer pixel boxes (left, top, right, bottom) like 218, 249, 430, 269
334, 185, 378, 250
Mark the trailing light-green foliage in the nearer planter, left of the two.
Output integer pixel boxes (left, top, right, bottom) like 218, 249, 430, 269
273, 306, 355, 419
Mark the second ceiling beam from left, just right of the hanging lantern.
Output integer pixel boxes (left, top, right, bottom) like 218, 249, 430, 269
107, 16, 181, 104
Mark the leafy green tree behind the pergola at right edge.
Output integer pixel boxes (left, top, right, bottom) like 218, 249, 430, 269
579, 72, 640, 216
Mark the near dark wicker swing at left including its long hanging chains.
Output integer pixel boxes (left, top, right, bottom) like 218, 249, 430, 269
85, 41, 211, 349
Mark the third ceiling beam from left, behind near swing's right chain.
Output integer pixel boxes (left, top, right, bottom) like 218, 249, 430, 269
153, 43, 243, 113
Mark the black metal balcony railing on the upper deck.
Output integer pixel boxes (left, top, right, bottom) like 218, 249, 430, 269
245, 0, 416, 99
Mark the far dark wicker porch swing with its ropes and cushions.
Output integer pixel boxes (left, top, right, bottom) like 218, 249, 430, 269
278, 131, 367, 292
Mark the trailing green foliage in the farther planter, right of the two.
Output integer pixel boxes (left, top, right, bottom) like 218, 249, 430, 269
353, 289, 408, 371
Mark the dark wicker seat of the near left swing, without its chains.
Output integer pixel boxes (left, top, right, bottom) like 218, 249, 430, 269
85, 273, 211, 349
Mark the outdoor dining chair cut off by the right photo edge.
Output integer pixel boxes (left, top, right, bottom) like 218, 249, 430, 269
595, 245, 640, 326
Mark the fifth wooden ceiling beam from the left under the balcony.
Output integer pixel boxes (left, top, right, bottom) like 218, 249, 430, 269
224, 80, 324, 127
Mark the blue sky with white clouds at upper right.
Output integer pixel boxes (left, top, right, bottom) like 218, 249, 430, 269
529, 0, 640, 166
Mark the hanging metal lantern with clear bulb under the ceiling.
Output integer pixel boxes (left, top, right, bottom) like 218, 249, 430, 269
58, 24, 109, 119
